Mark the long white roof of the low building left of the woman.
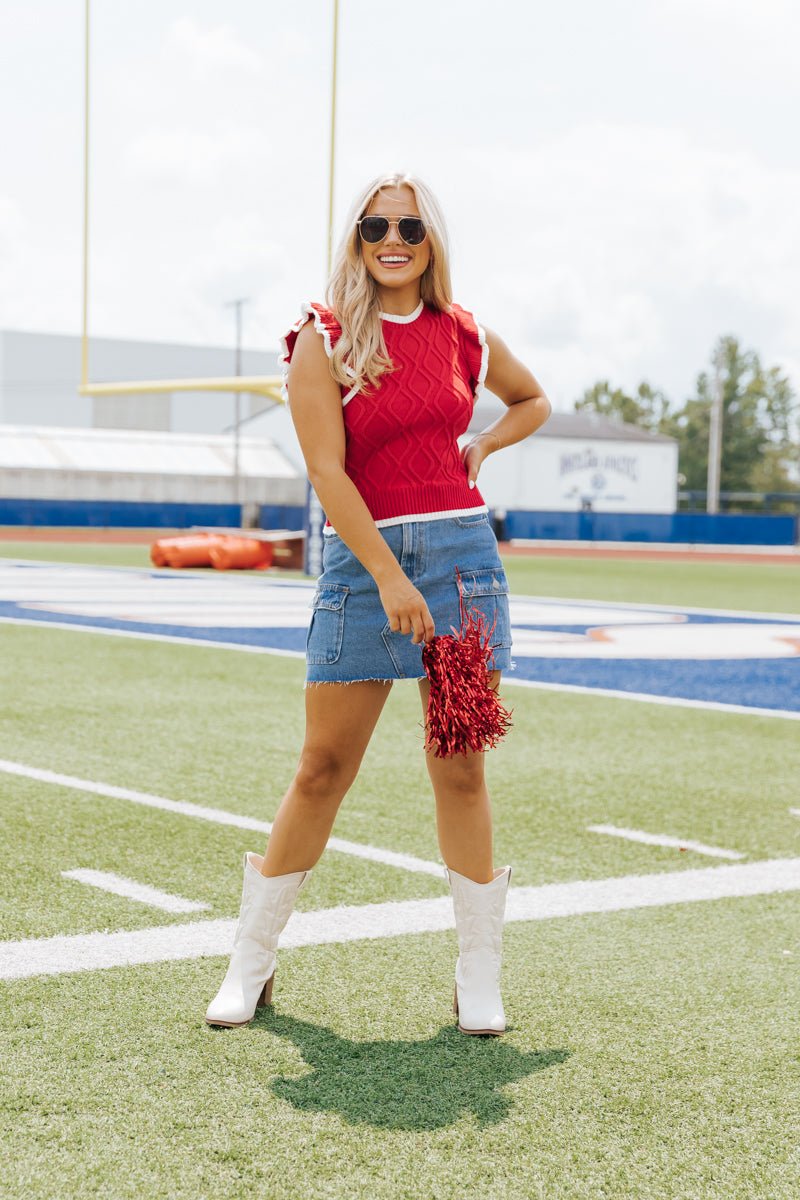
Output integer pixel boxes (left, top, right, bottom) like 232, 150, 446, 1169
0, 425, 299, 479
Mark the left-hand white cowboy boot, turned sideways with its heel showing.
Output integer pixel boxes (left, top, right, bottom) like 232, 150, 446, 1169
205, 851, 311, 1026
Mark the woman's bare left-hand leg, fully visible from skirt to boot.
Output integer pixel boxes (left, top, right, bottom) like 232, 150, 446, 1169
260, 679, 391, 875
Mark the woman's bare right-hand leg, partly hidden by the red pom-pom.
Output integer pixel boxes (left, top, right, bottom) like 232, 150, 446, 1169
420, 671, 501, 883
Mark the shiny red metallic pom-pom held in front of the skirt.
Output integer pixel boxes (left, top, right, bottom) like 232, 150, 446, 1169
422, 568, 511, 758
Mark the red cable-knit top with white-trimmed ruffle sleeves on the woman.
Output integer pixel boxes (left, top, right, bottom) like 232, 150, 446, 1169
281, 300, 488, 532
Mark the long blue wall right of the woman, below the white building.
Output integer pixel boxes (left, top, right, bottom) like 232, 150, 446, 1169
504, 511, 800, 546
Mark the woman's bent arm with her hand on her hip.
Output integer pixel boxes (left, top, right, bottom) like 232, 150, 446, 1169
462, 329, 552, 486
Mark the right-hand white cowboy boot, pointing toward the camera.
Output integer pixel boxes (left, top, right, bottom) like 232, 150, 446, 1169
445, 866, 511, 1033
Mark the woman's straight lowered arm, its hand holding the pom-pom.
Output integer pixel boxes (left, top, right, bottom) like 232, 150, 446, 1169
288, 322, 434, 644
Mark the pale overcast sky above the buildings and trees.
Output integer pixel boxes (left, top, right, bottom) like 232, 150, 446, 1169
0, 0, 800, 408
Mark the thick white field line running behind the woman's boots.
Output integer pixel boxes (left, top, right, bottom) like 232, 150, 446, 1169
0, 858, 800, 979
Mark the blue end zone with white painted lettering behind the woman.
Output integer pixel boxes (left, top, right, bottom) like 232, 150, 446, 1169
0, 560, 800, 716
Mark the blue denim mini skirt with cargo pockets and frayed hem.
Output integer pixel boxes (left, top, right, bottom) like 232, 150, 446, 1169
306, 512, 513, 684
